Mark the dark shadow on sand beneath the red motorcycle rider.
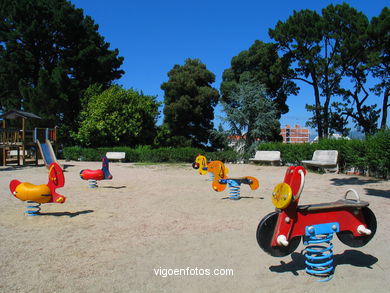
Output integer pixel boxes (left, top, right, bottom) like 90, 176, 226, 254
269, 249, 378, 276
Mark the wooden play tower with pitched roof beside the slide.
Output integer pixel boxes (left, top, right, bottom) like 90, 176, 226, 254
0, 110, 57, 166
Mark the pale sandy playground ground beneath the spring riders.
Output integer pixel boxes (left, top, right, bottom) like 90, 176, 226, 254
0, 161, 390, 292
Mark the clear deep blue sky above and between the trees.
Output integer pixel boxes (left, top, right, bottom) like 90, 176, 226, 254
70, 0, 390, 127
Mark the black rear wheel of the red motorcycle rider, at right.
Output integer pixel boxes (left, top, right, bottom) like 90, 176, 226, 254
336, 207, 377, 247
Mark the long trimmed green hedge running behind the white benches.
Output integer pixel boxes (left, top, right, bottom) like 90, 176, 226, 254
63, 129, 390, 178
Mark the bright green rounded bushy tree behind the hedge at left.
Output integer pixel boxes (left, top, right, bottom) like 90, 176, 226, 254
73, 86, 159, 147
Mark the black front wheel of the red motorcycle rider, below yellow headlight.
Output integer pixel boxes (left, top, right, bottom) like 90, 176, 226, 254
256, 212, 301, 257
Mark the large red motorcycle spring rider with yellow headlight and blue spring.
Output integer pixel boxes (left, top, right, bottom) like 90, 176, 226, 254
256, 166, 377, 281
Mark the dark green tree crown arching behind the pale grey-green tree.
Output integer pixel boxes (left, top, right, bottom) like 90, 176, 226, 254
220, 41, 297, 118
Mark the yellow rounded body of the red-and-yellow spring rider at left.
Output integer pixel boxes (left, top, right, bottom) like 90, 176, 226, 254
14, 182, 51, 203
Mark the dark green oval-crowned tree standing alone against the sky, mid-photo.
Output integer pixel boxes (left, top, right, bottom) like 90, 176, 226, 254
161, 58, 219, 147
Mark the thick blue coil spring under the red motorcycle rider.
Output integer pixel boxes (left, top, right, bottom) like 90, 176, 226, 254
304, 233, 334, 282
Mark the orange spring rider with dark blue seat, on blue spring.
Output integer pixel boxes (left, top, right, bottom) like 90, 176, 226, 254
208, 161, 259, 200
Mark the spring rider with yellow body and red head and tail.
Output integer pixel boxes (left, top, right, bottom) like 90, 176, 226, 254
9, 163, 66, 216
